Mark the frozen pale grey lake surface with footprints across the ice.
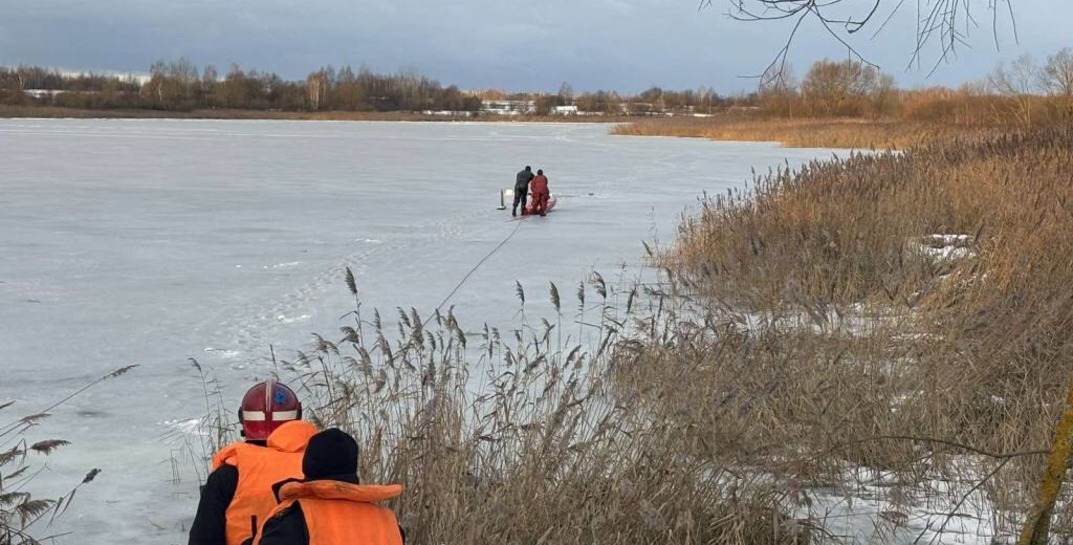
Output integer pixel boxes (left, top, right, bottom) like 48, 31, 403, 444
0, 120, 831, 544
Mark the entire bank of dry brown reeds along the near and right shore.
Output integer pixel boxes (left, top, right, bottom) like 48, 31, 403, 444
261, 124, 1073, 544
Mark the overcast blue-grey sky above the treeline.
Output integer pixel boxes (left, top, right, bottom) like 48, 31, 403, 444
0, 0, 1073, 92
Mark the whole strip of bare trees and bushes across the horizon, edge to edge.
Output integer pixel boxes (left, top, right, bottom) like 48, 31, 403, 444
0, 48, 1073, 119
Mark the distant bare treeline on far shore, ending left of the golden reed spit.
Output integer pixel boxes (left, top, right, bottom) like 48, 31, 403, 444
0, 59, 741, 115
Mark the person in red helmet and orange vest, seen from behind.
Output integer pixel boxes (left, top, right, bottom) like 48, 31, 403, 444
189, 380, 317, 545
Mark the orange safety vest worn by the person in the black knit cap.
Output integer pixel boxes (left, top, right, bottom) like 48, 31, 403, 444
254, 481, 402, 545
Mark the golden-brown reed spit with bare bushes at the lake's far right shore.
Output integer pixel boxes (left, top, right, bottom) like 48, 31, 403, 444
614, 49, 1073, 149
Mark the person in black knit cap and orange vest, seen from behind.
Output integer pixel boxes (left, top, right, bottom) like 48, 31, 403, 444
254, 428, 406, 545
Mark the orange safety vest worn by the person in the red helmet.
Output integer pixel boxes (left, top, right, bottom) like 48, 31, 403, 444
212, 421, 317, 545
